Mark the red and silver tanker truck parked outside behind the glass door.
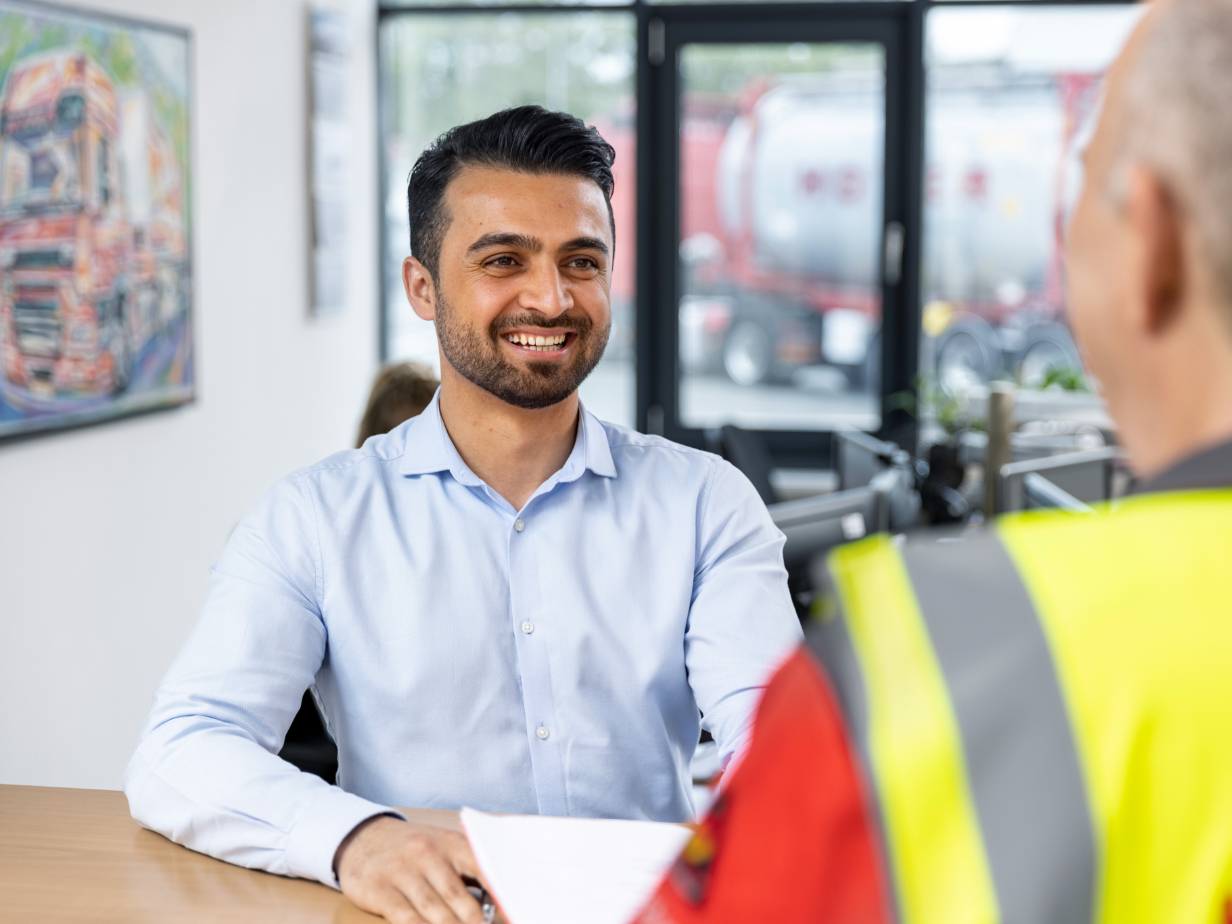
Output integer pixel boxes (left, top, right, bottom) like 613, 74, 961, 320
680, 69, 1095, 388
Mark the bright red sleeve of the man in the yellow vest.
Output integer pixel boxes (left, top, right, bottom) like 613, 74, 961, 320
637, 648, 893, 924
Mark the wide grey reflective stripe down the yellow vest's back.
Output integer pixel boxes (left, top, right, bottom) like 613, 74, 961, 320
903, 532, 1095, 924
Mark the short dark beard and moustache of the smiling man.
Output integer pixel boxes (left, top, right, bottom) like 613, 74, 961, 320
436, 291, 611, 409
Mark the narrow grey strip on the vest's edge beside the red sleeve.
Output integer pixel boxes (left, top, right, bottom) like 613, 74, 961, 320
804, 615, 903, 922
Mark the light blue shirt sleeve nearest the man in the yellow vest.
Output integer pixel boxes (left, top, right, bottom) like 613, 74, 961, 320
685, 461, 802, 766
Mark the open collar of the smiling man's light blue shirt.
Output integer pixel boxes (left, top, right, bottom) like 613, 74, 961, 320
398, 388, 616, 488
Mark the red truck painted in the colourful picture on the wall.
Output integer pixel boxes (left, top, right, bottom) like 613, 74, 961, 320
0, 51, 187, 410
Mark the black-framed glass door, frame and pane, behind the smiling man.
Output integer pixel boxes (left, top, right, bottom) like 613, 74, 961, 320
643, 5, 921, 463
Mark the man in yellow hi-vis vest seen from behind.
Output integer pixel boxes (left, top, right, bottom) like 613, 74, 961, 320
638, 0, 1232, 924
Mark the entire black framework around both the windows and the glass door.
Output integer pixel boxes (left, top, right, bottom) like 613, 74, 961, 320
376, 0, 1132, 468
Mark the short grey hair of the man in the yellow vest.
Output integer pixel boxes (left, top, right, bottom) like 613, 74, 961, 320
1110, 0, 1232, 323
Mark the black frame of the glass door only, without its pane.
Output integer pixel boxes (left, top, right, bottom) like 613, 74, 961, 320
636, 2, 923, 468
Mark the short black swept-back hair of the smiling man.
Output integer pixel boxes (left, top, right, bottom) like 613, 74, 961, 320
407, 106, 616, 280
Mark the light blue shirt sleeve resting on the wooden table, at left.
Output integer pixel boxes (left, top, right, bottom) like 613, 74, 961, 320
124, 479, 391, 888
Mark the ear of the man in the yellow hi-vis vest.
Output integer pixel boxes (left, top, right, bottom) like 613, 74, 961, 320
1126, 165, 1186, 334
